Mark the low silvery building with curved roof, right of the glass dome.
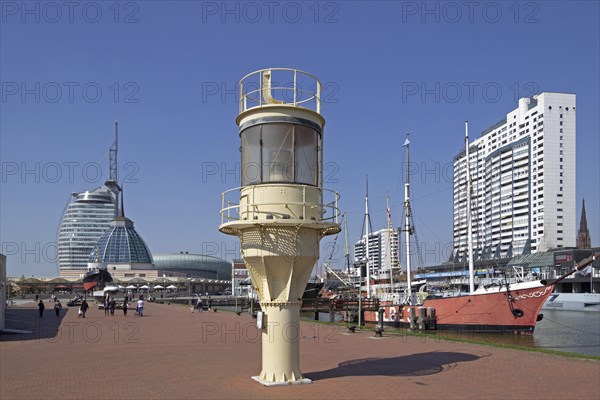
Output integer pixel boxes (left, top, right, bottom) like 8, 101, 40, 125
154, 252, 231, 280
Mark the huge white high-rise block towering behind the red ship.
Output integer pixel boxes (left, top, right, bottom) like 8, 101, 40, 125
453, 93, 576, 259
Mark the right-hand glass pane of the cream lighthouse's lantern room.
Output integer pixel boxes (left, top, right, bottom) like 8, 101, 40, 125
294, 125, 318, 186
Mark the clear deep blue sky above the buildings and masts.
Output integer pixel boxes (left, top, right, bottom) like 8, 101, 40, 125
0, 1, 600, 276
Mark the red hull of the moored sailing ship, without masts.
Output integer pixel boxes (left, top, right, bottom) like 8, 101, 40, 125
365, 285, 554, 334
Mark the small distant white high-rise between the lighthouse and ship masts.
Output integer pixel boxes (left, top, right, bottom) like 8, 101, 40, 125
354, 229, 400, 275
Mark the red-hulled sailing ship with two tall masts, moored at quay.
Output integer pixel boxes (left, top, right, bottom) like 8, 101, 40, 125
358, 126, 593, 334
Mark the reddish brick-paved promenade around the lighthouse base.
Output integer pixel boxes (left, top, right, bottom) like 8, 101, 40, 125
0, 303, 600, 400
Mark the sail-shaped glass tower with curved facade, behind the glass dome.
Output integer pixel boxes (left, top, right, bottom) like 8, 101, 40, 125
58, 185, 117, 276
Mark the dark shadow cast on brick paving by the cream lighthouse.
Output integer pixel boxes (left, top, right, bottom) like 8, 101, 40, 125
304, 351, 480, 380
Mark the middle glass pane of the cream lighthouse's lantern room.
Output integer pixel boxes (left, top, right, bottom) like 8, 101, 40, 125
262, 124, 294, 182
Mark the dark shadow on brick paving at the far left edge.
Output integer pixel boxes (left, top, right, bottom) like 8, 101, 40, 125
0, 303, 71, 341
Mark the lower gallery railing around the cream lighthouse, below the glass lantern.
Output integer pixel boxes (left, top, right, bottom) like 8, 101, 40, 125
220, 185, 341, 225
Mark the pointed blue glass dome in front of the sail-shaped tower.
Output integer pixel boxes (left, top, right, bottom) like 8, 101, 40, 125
88, 217, 152, 264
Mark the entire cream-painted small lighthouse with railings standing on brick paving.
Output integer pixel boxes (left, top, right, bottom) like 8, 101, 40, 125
219, 68, 341, 386
